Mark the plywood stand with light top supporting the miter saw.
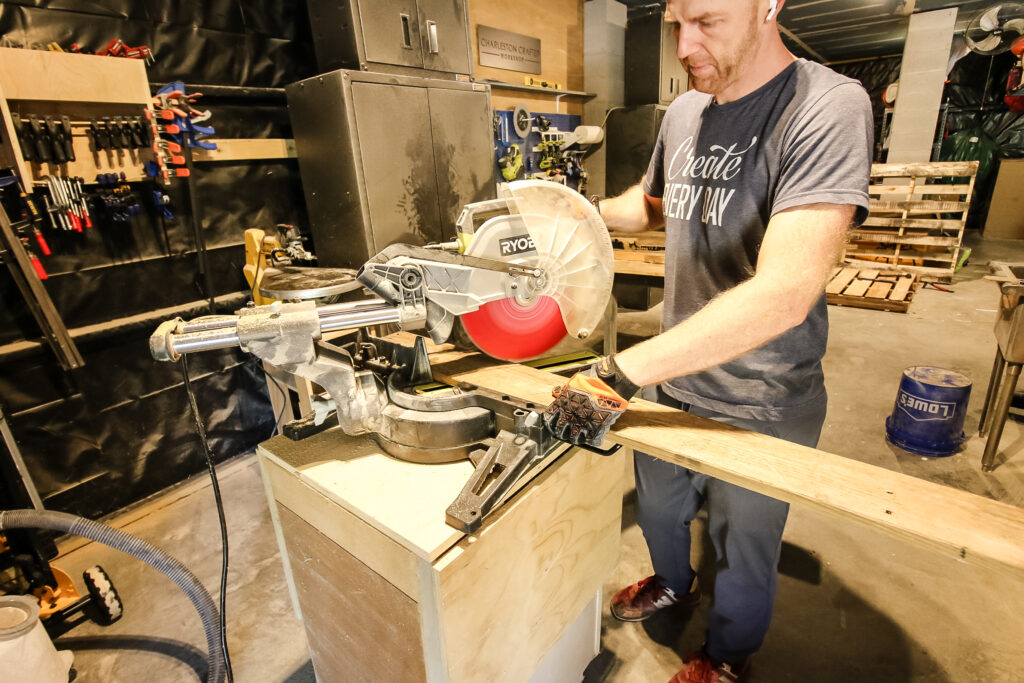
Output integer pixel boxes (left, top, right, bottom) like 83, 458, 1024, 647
258, 428, 624, 683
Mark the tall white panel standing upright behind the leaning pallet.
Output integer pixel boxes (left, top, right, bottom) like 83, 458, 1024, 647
888, 7, 956, 163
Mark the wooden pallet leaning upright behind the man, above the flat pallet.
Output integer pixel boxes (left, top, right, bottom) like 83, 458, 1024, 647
844, 162, 978, 276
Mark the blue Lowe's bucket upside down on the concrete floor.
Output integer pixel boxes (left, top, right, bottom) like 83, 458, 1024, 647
886, 366, 971, 458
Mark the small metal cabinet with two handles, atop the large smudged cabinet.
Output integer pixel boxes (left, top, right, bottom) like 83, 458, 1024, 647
307, 0, 472, 75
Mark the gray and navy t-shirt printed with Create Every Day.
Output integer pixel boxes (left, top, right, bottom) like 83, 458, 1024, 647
644, 59, 872, 421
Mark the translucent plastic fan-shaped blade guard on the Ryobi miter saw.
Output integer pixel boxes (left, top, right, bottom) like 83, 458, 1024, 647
499, 180, 614, 339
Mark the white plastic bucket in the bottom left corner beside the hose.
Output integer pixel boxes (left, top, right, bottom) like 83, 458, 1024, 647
0, 595, 75, 683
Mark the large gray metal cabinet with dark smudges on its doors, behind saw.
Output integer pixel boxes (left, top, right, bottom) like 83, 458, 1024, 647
287, 70, 496, 267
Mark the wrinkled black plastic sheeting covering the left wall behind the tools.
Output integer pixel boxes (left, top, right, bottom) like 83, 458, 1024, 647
0, 0, 315, 517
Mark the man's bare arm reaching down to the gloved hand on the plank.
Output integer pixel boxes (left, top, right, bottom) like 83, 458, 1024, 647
601, 202, 854, 386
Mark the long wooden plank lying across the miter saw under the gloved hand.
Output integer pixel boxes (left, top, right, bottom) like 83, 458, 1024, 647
432, 352, 1024, 577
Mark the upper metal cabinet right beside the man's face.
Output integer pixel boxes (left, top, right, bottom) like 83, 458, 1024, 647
626, 5, 689, 104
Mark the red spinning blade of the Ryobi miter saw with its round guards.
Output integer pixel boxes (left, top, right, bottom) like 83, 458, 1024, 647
461, 180, 614, 360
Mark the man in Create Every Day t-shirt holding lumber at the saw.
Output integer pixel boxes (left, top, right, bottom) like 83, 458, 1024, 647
548, 0, 872, 683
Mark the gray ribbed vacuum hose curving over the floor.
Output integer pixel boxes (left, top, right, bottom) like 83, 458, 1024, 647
0, 510, 225, 683
